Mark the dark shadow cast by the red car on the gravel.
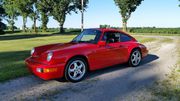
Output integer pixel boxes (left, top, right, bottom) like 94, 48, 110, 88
87, 54, 159, 79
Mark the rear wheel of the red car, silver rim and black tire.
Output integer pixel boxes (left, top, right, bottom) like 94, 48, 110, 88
129, 49, 142, 67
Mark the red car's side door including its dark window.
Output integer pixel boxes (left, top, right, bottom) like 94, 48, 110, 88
90, 32, 127, 70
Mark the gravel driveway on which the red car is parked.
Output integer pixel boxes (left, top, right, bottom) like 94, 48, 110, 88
0, 36, 180, 101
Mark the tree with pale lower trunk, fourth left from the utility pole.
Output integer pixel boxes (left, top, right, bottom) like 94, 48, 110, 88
16, 0, 32, 32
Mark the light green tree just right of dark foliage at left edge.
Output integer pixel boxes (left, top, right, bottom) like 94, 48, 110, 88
3, 0, 19, 32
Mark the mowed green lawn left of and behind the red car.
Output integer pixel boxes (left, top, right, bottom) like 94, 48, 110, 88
0, 33, 155, 82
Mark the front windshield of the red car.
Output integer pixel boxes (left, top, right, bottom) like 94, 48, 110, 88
72, 29, 101, 43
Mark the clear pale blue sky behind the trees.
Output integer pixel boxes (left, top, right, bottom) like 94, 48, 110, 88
4, 0, 180, 28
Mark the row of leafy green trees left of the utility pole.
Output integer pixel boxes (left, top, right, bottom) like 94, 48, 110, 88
0, 0, 88, 33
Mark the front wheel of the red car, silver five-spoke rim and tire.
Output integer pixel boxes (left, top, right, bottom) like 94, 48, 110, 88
65, 58, 87, 82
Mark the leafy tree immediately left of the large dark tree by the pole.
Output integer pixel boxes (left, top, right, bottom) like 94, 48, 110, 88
37, 0, 52, 32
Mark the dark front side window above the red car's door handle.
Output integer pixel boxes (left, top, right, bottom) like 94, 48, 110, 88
102, 32, 120, 43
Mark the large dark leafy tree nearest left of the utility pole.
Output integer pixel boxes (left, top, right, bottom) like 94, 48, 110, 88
49, 0, 75, 33
